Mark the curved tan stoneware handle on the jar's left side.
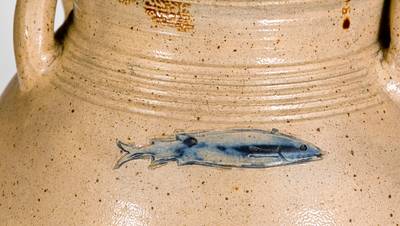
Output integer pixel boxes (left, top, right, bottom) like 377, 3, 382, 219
14, 0, 62, 90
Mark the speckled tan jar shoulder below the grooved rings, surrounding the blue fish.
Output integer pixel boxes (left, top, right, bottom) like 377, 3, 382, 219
0, 77, 400, 225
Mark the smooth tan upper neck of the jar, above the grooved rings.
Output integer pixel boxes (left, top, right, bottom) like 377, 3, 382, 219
67, 0, 383, 67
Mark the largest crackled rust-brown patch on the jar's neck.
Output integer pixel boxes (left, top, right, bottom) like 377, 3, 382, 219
144, 0, 194, 31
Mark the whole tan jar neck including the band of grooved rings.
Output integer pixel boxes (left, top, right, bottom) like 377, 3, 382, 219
50, 0, 383, 123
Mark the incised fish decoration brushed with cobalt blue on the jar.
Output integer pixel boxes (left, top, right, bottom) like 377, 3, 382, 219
114, 129, 322, 169
